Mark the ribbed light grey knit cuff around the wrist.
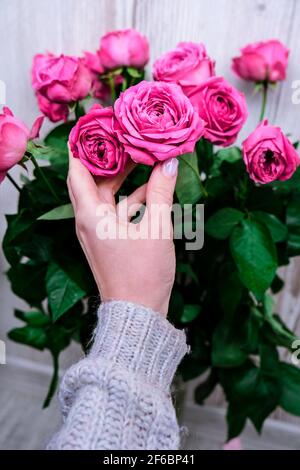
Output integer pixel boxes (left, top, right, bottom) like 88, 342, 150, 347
89, 300, 187, 389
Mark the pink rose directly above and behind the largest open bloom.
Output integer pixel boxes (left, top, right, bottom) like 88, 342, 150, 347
153, 42, 215, 94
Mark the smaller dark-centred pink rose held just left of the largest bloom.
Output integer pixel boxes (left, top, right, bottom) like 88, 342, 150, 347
69, 104, 128, 176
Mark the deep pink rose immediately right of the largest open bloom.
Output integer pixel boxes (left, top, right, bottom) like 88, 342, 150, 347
189, 77, 248, 147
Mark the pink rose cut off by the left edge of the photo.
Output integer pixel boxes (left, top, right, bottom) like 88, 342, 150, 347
0, 107, 43, 183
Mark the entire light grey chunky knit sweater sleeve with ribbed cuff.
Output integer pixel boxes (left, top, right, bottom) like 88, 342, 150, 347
48, 301, 187, 450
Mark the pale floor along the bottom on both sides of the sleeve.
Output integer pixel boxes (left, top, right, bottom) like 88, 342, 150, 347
0, 365, 300, 450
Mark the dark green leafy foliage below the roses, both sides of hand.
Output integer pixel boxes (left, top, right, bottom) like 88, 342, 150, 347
3, 73, 300, 438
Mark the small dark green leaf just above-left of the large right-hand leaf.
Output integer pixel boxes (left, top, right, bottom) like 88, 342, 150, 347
205, 207, 244, 240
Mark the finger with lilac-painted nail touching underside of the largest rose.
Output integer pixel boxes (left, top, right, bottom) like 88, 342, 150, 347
146, 158, 178, 206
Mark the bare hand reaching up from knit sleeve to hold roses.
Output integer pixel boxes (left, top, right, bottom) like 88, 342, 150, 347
68, 153, 178, 315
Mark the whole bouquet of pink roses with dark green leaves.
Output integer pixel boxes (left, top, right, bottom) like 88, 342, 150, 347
0, 29, 300, 438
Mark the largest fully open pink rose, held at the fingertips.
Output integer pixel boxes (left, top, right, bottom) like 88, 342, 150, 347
115, 81, 203, 165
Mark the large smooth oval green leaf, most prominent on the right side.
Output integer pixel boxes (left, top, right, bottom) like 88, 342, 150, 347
230, 219, 277, 296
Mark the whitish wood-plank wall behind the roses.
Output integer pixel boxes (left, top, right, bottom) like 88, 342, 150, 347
0, 0, 300, 426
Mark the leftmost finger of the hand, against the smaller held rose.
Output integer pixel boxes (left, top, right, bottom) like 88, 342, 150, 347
67, 144, 99, 211
